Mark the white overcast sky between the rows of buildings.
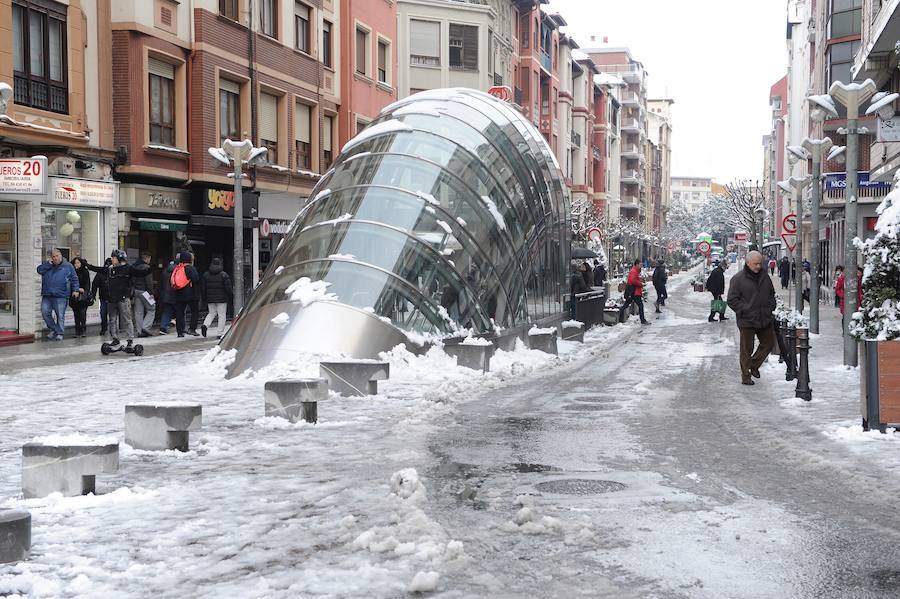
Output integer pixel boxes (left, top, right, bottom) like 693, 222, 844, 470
550, 0, 787, 183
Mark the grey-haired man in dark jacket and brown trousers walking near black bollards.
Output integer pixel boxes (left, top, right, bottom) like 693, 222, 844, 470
728, 252, 775, 385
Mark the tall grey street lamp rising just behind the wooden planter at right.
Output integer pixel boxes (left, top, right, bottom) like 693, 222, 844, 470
810, 79, 878, 366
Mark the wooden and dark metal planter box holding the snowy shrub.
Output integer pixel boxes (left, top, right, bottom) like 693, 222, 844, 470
859, 340, 900, 432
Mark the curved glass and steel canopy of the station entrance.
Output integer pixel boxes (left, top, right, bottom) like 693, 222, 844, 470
223, 89, 571, 370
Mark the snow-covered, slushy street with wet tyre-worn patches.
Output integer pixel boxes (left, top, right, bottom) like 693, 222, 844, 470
0, 266, 900, 599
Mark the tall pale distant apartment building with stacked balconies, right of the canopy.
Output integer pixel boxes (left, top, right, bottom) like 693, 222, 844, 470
584, 47, 649, 223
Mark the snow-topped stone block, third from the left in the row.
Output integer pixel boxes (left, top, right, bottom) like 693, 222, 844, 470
125, 403, 202, 451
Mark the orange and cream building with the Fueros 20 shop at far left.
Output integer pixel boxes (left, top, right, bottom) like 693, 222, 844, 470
0, 0, 119, 344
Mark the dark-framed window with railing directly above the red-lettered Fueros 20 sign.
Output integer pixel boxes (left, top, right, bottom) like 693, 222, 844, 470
12, 0, 69, 114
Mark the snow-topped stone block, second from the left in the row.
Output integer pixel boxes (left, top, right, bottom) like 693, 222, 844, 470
22, 438, 119, 499
